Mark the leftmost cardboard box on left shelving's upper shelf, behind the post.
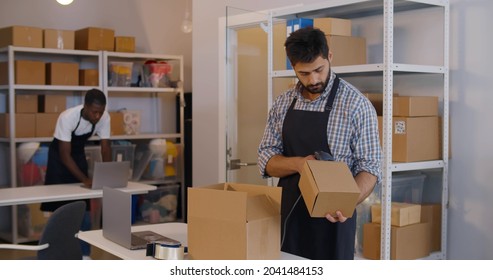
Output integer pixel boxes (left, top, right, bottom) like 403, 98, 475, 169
0, 60, 45, 85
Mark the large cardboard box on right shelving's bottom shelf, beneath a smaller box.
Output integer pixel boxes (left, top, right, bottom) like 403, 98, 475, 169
363, 223, 430, 260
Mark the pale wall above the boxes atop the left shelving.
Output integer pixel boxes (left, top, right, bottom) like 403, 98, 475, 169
0, 0, 192, 92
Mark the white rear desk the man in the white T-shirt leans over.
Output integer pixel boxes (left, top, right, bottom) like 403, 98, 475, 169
0, 182, 156, 206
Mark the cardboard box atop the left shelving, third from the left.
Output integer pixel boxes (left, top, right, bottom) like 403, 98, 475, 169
75, 27, 115, 51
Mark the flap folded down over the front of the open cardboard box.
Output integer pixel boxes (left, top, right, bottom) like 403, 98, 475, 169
188, 184, 247, 223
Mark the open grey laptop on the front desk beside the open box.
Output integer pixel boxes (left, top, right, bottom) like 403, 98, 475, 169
103, 187, 181, 250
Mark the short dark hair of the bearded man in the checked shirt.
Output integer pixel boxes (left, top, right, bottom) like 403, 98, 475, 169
284, 27, 329, 66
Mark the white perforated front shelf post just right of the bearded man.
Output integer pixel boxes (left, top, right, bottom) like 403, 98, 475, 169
380, 0, 394, 260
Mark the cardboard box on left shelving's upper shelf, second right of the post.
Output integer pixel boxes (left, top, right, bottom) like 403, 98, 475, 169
46, 62, 79, 86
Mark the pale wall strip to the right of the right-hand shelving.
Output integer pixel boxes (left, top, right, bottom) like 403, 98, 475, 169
448, 0, 493, 260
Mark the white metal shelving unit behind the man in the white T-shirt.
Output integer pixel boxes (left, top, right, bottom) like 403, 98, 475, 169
0, 46, 185, 244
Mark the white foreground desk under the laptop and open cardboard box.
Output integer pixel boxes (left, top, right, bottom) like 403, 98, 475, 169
78, 223, 303, 260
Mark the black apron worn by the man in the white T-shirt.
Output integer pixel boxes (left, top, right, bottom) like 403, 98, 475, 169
41, 110, 95, 212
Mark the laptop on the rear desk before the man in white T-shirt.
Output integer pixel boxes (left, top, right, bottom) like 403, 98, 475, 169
91, 161, 130, 190
